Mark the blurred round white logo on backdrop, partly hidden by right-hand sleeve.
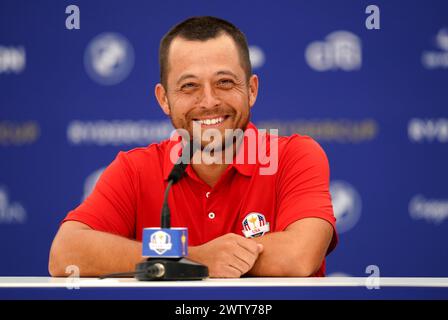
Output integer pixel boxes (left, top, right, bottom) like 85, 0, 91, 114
330, 181, 362, 233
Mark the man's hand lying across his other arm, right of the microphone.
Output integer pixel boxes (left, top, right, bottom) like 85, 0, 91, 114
188, 233, 263, 278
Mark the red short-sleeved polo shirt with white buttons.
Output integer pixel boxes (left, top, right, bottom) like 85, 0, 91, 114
64, 123, 338, 276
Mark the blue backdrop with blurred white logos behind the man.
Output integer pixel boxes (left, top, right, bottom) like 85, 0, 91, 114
0, 0, 448, 276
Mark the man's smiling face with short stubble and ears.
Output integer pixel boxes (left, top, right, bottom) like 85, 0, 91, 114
156, 34, 258, 149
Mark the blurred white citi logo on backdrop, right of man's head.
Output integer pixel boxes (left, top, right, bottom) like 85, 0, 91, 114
305, 31, 362, 71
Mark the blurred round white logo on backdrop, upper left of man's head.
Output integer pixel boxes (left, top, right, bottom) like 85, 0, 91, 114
84, 33, 134, 85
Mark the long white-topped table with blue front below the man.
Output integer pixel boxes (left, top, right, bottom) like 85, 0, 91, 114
0, 277, 448, 300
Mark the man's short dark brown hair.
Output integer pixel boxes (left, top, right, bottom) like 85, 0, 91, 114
159, 16, 252, 88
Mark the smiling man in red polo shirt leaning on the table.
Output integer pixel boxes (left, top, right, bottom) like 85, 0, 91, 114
49, 17, 337, 277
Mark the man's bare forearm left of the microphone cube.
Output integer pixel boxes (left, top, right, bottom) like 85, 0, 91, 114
49, 230, 142, 277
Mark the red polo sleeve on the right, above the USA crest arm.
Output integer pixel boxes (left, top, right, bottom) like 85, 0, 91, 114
276, 135, 338, 254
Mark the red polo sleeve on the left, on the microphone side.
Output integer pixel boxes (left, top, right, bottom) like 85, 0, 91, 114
62, 152, 138, 238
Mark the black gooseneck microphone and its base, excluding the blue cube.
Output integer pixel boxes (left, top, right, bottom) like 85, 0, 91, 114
134, 141, 209, 281
